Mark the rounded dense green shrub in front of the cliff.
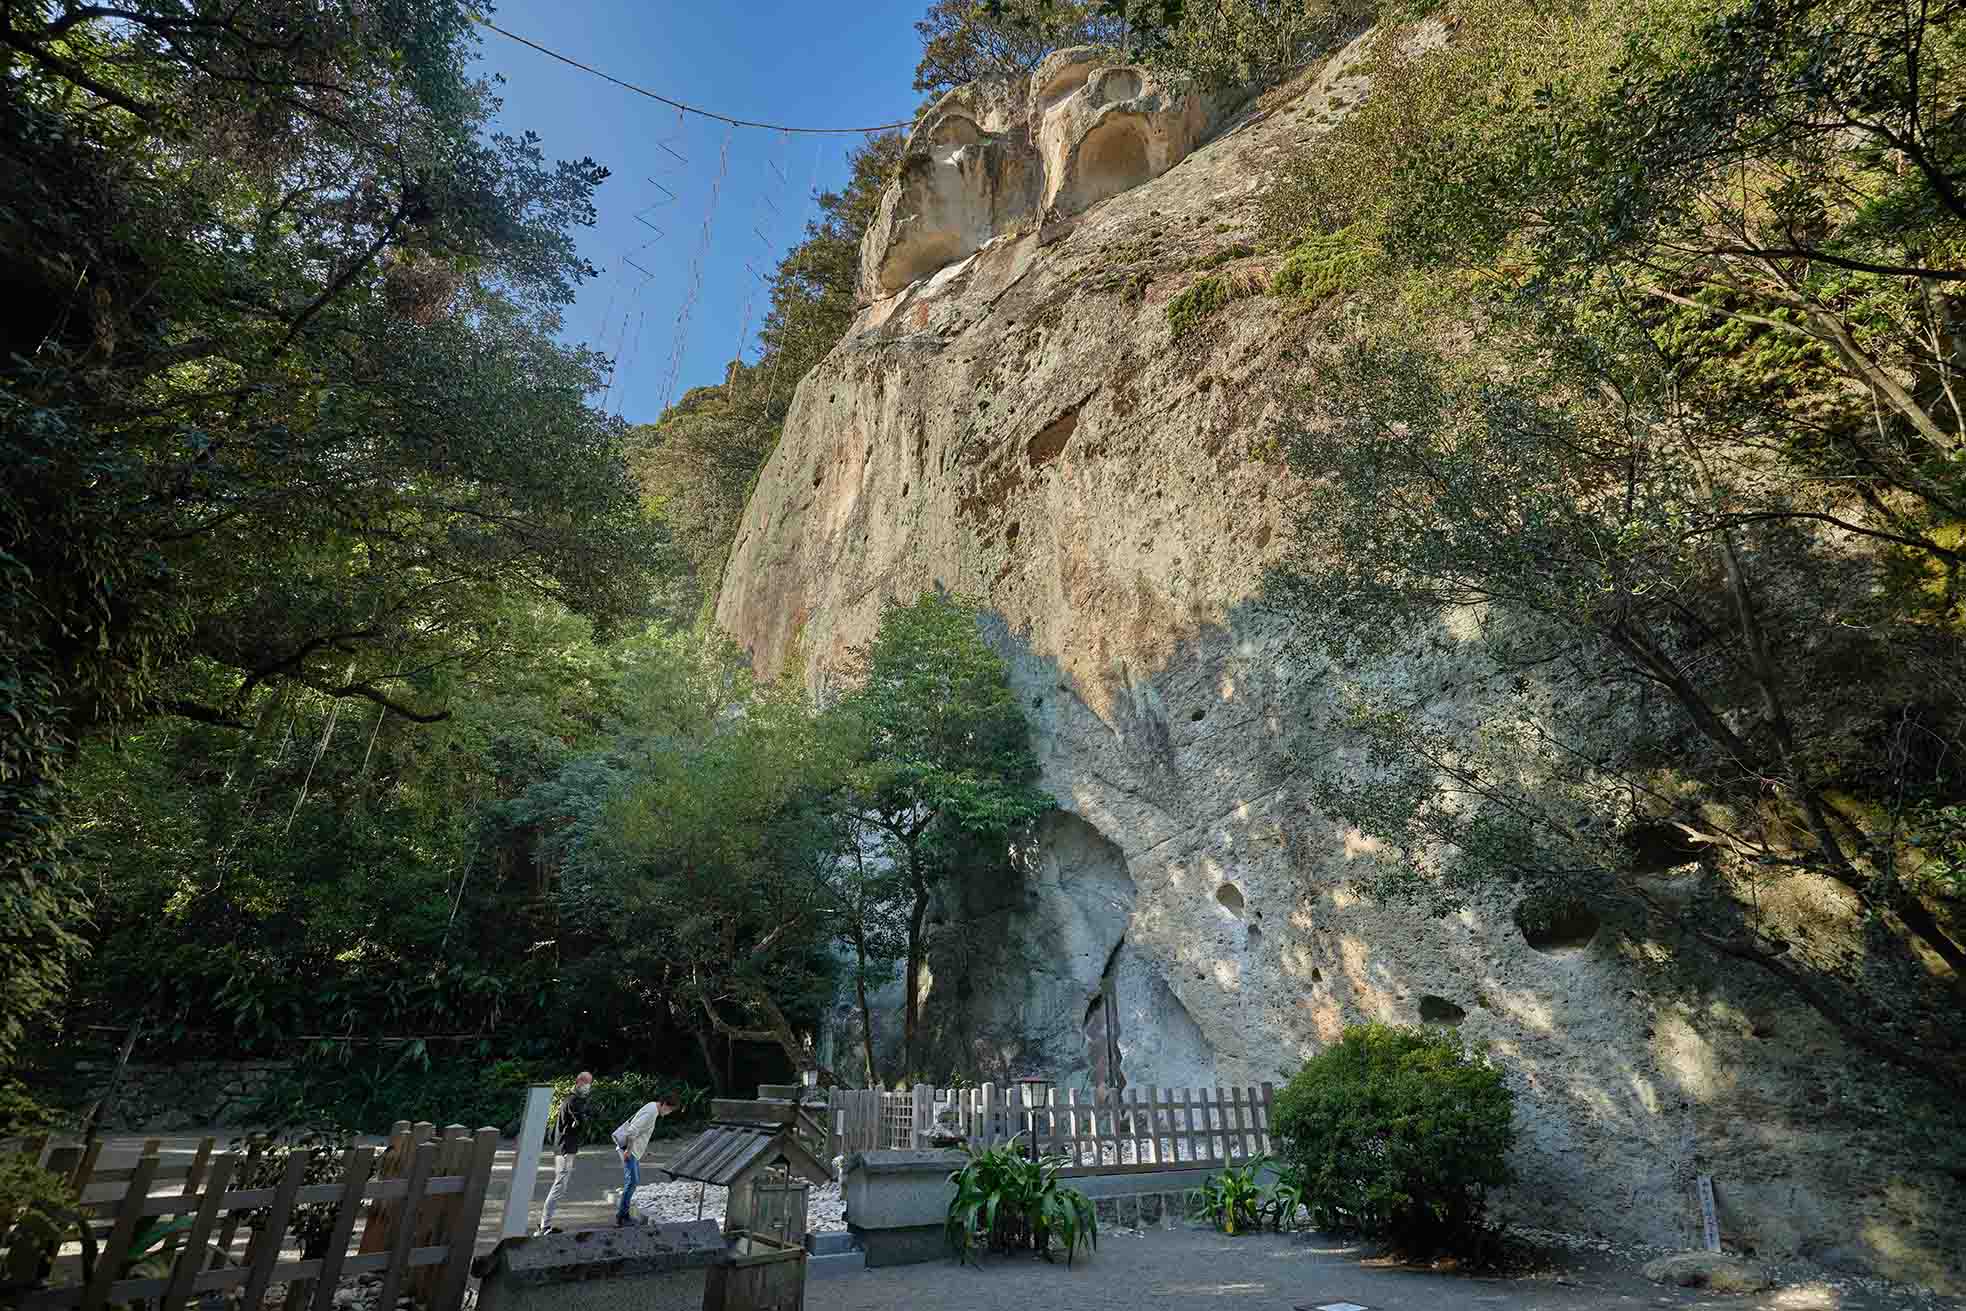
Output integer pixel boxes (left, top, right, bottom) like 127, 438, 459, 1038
1276, 1024, 1516, 1252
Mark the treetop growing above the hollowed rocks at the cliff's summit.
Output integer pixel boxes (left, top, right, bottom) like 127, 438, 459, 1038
914, 0, 1127, 92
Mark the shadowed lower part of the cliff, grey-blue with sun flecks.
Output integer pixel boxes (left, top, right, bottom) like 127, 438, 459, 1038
900, 601, 1966, 1289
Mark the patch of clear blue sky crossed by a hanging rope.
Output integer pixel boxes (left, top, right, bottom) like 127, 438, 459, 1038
480, 0, 928, 423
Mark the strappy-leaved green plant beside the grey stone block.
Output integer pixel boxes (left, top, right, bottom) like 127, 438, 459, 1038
946, 1138, 1099, 1266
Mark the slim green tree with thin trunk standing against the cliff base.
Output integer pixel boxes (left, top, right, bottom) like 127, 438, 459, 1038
834, 592, 1056, 1073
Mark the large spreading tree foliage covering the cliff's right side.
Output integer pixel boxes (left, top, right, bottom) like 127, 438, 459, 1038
1276, 0, 1966, 1087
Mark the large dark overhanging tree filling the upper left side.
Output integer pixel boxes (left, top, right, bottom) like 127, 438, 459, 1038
0, 0, 661, 1069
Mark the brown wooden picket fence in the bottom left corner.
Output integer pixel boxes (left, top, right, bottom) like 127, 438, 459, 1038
0, 1120, 497, 1311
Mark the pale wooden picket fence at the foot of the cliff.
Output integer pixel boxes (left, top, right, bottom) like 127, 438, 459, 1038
828, 1083, 1276, 1175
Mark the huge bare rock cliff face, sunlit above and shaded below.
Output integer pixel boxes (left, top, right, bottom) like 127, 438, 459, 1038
718, 28, 1966, 1287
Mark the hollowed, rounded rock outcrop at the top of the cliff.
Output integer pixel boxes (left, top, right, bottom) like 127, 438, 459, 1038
861, 45, 1219, 299
